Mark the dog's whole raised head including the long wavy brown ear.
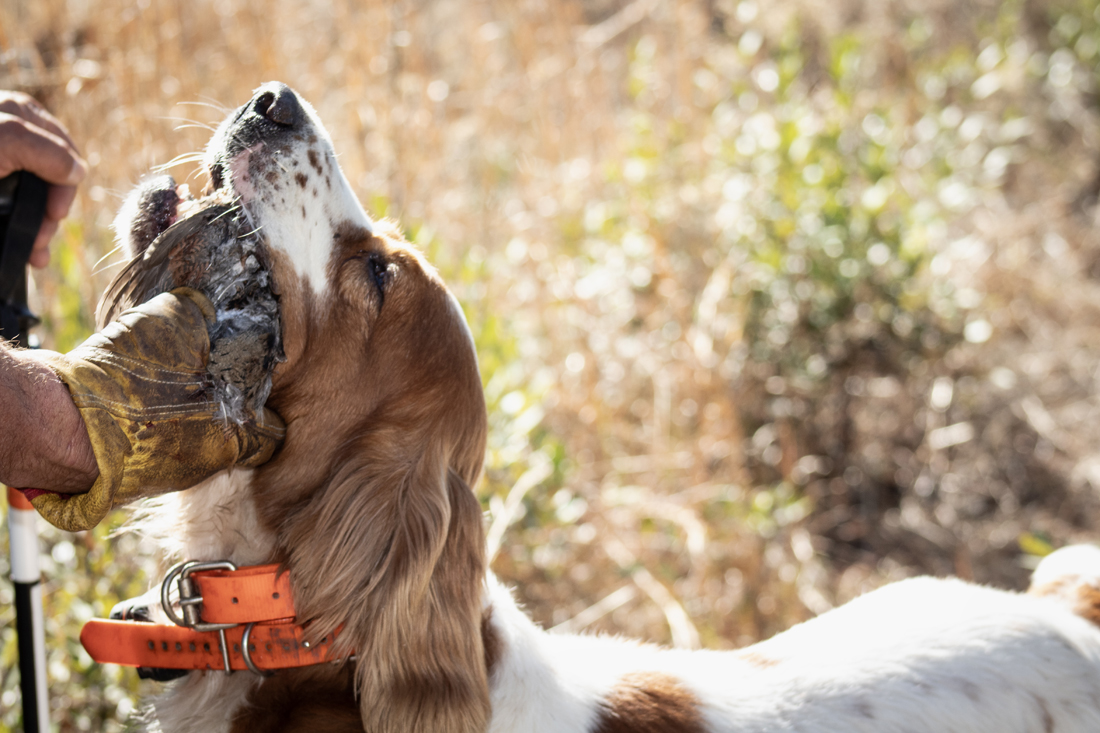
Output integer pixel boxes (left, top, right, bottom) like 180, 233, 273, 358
111, 83, 488, 731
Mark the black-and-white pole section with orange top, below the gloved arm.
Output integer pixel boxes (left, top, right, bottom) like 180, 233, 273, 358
8, 489, 50, 733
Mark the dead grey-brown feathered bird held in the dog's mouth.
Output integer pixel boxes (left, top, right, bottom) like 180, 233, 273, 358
96, 176, 285, 423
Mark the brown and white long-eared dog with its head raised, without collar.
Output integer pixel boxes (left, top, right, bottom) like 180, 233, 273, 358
107, 84, 1100, 733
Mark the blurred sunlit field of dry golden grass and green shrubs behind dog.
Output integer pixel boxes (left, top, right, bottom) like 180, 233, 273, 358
0, 0, 1100, 731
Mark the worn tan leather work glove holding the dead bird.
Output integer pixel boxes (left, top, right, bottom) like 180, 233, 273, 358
31, 287, 286, 532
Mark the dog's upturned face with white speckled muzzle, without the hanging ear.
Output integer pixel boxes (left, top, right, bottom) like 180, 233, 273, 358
199, 83, 485, 479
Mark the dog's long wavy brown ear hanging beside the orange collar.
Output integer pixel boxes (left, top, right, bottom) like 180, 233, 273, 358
286, 429, 490, 733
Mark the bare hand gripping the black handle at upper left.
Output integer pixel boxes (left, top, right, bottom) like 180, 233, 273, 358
0, 89, 88, 267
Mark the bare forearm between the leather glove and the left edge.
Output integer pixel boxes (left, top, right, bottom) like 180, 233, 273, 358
0, 343, 99, 493
